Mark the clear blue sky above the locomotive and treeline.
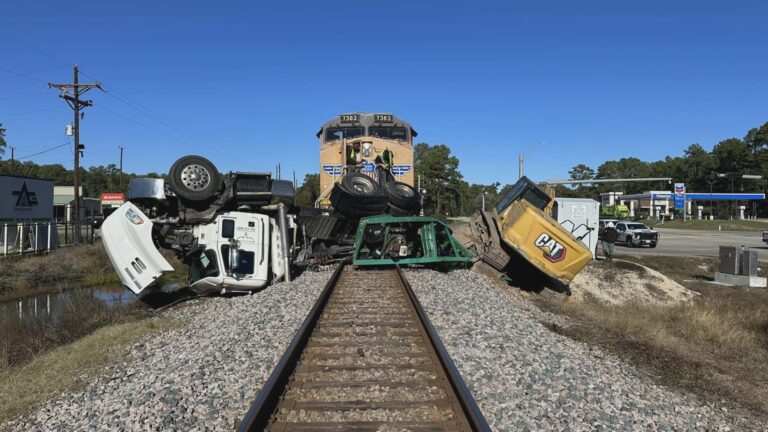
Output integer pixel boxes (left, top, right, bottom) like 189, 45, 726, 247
0, 0, 768, 184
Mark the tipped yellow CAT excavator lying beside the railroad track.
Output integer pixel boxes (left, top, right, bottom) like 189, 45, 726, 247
459, 177, 592, 292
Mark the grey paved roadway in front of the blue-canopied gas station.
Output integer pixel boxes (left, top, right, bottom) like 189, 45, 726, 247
612, 228, 768, 261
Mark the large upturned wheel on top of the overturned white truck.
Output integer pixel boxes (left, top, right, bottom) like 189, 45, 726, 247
168, 156, 221, 202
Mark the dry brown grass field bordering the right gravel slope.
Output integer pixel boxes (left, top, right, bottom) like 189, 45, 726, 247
536, 257, 768, 416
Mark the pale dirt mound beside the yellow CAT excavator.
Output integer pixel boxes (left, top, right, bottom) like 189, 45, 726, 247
570, 260, 698, 304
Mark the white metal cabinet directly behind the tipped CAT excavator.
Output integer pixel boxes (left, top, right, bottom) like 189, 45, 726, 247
552, 197, 600, 259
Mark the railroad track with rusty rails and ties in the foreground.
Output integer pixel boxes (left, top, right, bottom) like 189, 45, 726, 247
238, 265, 490, 431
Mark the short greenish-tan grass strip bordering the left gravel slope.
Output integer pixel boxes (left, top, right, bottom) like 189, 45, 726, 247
0, 318, 178, 422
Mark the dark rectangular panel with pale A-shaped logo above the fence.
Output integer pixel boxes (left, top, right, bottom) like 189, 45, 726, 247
0, 175, 53, 223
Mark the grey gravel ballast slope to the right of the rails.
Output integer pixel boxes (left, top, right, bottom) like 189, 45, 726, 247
407, 270, 761, 431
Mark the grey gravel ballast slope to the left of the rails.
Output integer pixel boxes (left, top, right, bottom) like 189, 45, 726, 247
0, 271, 331, 432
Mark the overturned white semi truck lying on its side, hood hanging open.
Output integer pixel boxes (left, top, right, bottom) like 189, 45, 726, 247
101, 156, 295, 298
